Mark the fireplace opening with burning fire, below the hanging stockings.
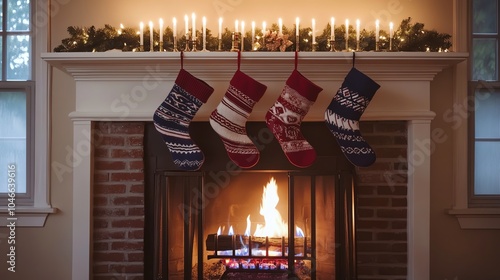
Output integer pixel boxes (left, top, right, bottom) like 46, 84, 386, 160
144, 123, 356, 279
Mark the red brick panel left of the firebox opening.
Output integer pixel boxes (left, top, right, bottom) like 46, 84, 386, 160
92, 122, 144, 280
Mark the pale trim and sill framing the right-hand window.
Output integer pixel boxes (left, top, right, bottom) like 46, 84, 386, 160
448, 0, 500, 229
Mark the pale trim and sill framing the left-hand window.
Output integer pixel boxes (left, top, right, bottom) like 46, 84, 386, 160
0, 0, 57, 227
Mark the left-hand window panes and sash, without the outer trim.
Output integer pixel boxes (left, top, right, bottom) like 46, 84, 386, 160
0, 0, 34, 205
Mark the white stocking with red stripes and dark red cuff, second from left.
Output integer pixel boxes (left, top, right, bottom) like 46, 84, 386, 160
210, 69, 267, 168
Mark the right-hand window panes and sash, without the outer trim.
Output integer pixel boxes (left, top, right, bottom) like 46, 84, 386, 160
469, 0, 500, 207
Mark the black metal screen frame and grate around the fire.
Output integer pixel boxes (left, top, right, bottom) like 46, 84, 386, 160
152, 170, 357, 280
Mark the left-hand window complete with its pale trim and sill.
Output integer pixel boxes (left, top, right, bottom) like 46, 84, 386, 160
0, 0, 55, 227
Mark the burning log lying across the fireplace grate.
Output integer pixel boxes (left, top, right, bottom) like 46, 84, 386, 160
205, 234, 311, 251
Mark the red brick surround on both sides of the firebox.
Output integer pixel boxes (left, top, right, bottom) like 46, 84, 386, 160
92, 121, 408, 280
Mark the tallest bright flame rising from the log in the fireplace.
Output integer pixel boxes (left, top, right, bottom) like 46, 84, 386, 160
254, 177, 288, 237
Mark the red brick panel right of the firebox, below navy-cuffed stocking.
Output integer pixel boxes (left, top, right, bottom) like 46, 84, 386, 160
356, 122, 408, 280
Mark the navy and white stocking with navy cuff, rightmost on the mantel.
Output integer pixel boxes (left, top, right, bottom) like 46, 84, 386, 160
325, 67, 380, 167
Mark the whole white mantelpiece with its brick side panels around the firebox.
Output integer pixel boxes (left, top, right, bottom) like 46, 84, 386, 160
43, 52, 466, 280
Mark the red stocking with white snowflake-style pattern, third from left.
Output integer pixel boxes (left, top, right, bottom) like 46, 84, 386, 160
266, 69, 323, 167
